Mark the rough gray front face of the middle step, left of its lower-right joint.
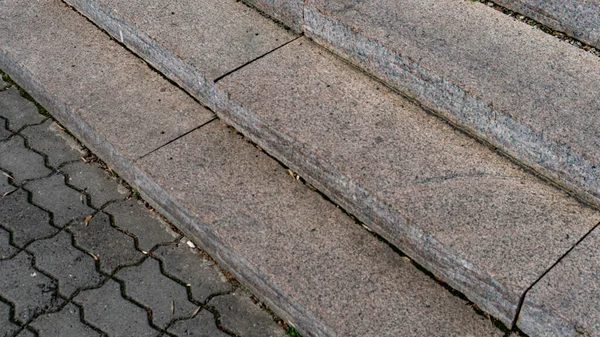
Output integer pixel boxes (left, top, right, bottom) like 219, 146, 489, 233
61, 0, 521, 326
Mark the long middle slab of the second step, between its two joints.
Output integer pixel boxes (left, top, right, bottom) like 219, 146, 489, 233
217, 39, 600, 325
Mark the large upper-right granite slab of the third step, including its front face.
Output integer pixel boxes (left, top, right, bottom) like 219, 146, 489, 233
305, 0, 600, 205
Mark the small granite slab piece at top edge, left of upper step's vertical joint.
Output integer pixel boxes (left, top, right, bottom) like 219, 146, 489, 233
245, 0, 304, 33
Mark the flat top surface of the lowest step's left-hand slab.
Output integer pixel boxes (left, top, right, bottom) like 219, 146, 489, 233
0, 0, 213, 161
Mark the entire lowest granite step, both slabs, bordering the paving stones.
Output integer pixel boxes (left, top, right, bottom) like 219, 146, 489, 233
0, 0, 510, 336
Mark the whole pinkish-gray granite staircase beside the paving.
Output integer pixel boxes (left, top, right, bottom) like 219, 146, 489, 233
0, 0, 600, 336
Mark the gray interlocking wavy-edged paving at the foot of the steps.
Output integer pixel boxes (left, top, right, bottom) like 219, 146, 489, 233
0, 80, 286, 337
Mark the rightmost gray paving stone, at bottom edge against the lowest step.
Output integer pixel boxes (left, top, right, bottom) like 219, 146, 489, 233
210, 290, 286, 337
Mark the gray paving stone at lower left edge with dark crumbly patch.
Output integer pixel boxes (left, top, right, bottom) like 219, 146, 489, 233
0, 252, 63, 323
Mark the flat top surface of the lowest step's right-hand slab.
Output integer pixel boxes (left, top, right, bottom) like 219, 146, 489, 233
136, 122, 502, 336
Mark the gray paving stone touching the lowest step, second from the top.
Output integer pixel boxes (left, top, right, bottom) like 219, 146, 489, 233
21, 119, 87, 168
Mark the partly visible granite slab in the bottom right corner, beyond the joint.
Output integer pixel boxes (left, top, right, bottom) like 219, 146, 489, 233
517, 223, 600, 336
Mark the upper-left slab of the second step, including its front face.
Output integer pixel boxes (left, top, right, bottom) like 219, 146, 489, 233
66, 0, 295, 103
